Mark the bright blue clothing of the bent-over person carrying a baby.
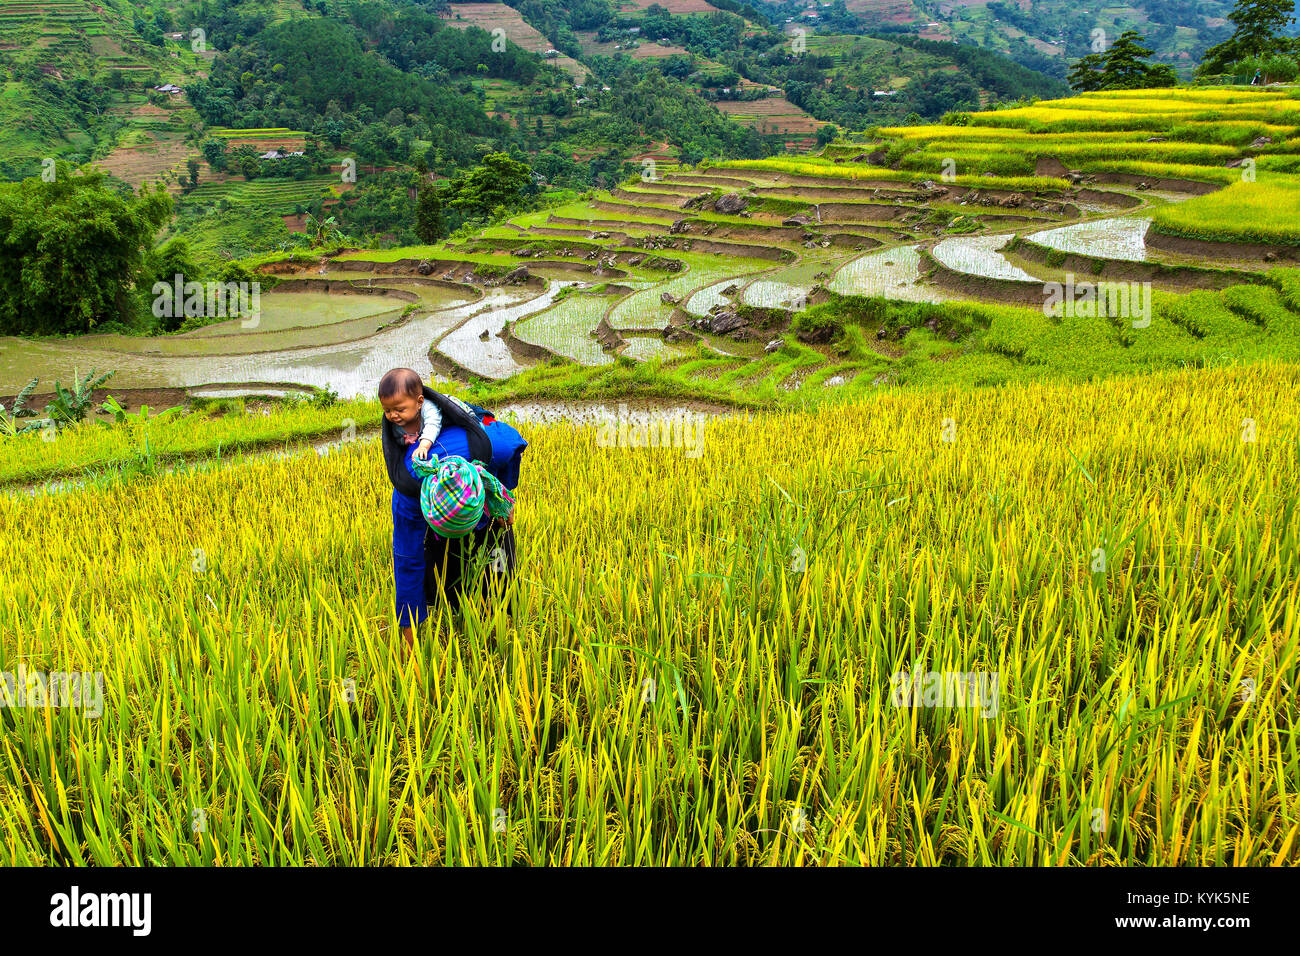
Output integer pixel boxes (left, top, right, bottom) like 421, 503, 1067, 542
385, 421, 528, 627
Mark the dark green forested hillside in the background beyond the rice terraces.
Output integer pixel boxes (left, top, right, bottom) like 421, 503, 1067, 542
0, 0, 1063, 260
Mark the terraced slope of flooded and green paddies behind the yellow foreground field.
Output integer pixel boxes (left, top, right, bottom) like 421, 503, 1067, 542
10, 82, 1300, 405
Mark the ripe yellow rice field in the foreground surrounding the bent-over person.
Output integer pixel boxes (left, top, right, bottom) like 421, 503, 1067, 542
0, 364, 1300, 865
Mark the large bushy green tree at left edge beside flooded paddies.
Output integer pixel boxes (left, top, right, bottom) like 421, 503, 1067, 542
0, 163, 172, 336
